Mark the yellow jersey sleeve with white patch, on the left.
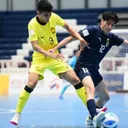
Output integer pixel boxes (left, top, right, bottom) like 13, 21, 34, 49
28, 24, 38, 41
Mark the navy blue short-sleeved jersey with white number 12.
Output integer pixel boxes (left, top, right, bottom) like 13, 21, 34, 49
76, 26, 124, 68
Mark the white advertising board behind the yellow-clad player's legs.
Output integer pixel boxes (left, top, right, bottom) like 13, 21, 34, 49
9, 70, 75, 95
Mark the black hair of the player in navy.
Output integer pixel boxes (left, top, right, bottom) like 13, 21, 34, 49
102, 12, 119, 24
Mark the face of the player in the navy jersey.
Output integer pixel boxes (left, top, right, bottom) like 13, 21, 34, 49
100, 19, 115, 34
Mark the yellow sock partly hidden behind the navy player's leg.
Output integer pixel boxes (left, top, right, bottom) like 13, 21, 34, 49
76, 87, 87, 106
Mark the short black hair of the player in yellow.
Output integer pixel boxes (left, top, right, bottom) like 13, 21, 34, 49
37, 0, 53, 13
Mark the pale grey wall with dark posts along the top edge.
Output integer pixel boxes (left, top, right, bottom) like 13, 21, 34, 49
0, 0, 128, 11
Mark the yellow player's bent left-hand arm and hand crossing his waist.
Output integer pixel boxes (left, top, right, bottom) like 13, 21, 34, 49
31, 40, 64, 59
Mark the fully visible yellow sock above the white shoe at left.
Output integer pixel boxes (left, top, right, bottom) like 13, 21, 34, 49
16, 90, 30, 113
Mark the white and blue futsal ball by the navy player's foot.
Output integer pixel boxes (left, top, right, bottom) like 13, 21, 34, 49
101, 113, 119, 128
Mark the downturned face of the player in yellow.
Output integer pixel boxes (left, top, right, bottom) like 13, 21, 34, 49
37, 12, 51, 23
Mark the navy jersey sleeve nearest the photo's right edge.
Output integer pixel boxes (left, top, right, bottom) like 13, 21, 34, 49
112, 34, 124, 46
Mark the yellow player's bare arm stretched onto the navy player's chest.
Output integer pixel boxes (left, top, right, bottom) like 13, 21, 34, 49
63, 22, 88, 48
